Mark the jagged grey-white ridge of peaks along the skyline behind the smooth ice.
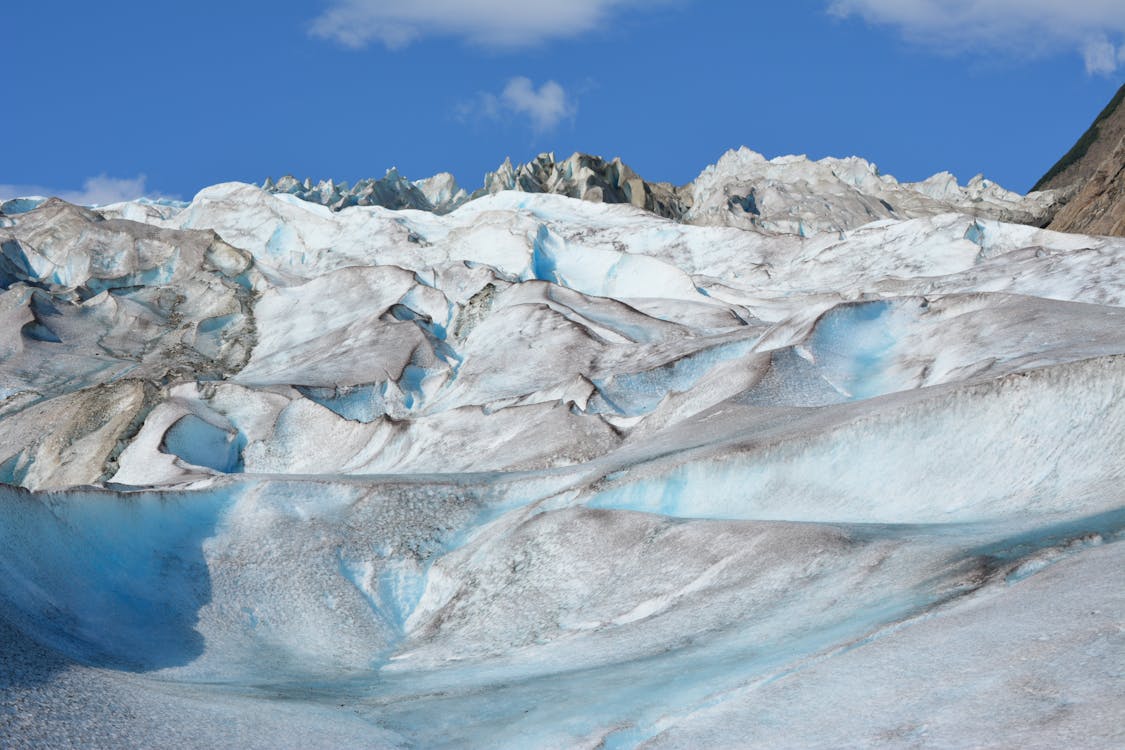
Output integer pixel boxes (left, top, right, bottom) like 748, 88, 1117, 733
262, 147, 1058, 235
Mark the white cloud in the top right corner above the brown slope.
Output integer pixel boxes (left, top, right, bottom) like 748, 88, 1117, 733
828, 0, 1125, 75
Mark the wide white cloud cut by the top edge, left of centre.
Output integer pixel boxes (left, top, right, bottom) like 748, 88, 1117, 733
311, 0, 680, 49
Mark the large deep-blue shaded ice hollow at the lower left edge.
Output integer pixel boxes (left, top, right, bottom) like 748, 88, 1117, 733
0, 487, 231, 670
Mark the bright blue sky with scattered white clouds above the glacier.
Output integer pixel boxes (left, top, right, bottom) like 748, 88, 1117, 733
0, 0, 1125, 201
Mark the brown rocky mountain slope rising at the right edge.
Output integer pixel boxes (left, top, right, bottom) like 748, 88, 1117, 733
1035, 85, 1125, 236
